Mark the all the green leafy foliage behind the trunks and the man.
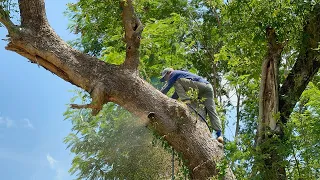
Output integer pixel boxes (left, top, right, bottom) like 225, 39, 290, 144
62, 0, 320, 179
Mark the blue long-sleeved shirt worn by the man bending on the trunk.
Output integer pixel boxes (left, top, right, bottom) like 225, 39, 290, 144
161, 70, 209, 99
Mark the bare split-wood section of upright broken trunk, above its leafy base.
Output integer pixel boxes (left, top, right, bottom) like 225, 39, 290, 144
257, 28, 283, 144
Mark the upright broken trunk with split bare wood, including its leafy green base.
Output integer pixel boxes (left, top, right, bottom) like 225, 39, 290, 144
256, 28, 286, 179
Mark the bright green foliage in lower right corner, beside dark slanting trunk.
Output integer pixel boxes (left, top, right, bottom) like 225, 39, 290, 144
288, 81, 320, 179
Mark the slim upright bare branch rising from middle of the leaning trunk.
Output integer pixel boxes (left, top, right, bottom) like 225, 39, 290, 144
121, 0, 143, 70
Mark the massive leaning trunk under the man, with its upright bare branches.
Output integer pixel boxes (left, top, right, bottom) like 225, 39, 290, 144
0, 0, 235, 179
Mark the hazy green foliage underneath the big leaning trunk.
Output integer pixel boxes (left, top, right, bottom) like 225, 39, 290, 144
65, 91, 176, 179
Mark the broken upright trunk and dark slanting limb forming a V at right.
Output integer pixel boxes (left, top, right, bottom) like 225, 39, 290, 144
256, 4, 320, 179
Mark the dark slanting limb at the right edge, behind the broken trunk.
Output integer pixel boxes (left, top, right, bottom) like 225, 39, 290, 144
279, 4, 320, 123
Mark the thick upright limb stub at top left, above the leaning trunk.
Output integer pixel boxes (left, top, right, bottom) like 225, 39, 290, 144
19, 0, 48, 30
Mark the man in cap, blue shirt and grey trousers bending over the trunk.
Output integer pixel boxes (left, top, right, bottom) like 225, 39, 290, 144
160, 68, 223, 143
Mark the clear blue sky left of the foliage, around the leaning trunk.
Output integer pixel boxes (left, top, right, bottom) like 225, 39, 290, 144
0, 0, 75, 180
